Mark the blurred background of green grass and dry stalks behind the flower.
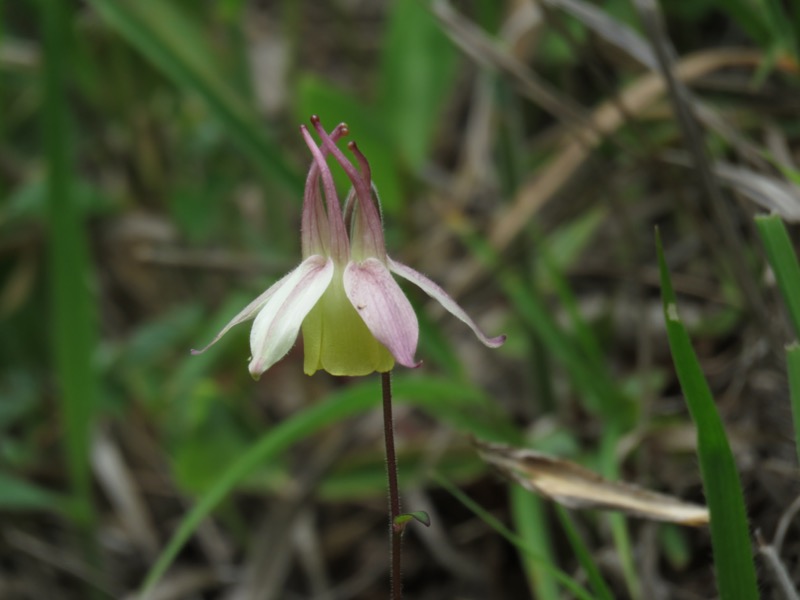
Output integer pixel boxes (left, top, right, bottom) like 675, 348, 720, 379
0, 0, 800, 599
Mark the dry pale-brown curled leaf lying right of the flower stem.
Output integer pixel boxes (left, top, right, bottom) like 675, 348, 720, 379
474, 440, 708, 527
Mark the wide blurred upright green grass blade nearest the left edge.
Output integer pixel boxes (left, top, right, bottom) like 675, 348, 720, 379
40, 2, 97, 525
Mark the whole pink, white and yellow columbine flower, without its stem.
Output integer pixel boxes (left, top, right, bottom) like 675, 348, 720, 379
192, 116, 505, 379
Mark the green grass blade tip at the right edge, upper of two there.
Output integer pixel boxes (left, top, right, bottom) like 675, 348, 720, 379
756, 215, 800, 337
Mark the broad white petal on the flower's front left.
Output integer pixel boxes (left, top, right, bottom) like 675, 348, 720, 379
250, 256, 334, 379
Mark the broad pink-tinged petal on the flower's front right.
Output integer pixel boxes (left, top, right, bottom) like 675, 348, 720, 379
344, 258, 420, 368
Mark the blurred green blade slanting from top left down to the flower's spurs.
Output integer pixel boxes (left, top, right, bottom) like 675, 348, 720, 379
90, 0, 304, 197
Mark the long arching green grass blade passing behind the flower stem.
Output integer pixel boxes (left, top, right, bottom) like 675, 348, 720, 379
141, 377, 510, 598
